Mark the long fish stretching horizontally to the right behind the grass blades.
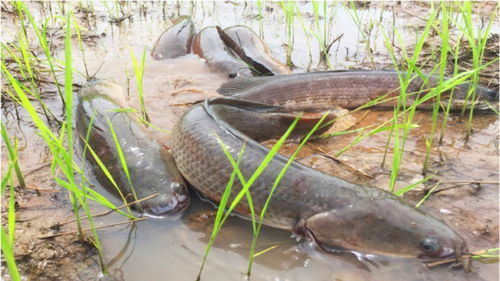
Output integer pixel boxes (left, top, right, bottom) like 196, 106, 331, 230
217, 70, 498, 110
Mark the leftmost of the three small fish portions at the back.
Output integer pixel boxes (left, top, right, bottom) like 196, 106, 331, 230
151, 17, 195, 60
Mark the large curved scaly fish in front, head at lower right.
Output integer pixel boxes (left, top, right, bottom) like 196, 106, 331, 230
171, 99, 467, 258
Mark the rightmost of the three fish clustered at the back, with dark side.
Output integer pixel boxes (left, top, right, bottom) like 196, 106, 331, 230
218, 25, 291, 76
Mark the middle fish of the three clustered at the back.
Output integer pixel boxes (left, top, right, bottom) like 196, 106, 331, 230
191, 26, 252, 78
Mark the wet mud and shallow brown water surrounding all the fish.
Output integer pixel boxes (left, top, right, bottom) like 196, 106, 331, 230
2, 2, 499, 280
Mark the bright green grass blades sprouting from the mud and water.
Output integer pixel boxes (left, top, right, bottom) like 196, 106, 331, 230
1, 1, 498, 280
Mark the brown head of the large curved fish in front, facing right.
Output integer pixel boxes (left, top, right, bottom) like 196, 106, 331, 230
306, 197, 467, 259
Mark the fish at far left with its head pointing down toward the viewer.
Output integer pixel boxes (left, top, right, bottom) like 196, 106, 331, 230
76, 81, 189, 216
